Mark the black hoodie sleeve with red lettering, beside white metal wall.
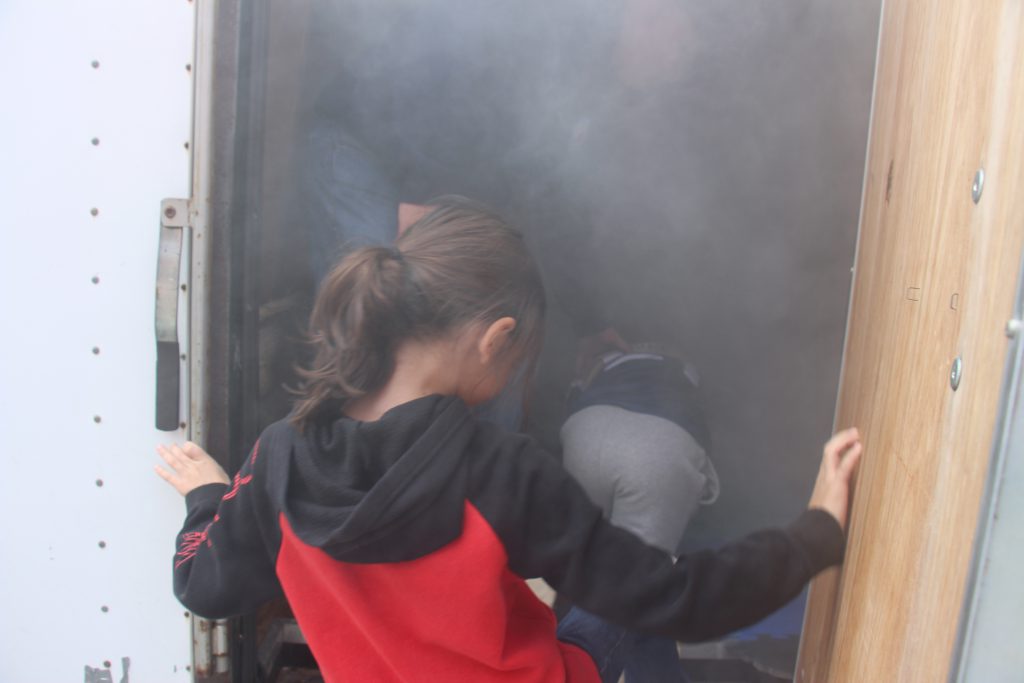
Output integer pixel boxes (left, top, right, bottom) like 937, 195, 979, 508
174, 443, 282, 618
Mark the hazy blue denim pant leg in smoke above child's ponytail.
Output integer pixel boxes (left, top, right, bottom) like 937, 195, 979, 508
298, 120, 398, 283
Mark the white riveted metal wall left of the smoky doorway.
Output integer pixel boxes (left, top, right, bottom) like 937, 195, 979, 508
0, 0, 194, 683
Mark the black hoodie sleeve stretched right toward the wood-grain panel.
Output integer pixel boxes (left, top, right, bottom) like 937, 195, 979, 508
474, 439, 844, 642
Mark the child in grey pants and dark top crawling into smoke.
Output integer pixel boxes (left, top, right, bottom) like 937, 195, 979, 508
561, 339, 719, 683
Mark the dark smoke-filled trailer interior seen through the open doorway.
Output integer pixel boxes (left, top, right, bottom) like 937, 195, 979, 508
209, 0, 879, 681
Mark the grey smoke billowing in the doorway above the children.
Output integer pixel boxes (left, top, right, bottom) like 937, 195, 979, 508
256, 0, 879, 538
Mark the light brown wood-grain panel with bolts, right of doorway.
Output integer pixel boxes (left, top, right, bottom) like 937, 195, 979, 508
796, 0, 1024, 683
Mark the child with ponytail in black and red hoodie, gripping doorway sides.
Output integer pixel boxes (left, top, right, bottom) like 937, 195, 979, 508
158, 198, 860, 683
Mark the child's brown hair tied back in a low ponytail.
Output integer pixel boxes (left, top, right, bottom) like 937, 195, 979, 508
290, 196, 546, 428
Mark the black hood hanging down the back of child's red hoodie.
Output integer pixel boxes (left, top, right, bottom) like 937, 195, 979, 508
269, 395, 475, 562
